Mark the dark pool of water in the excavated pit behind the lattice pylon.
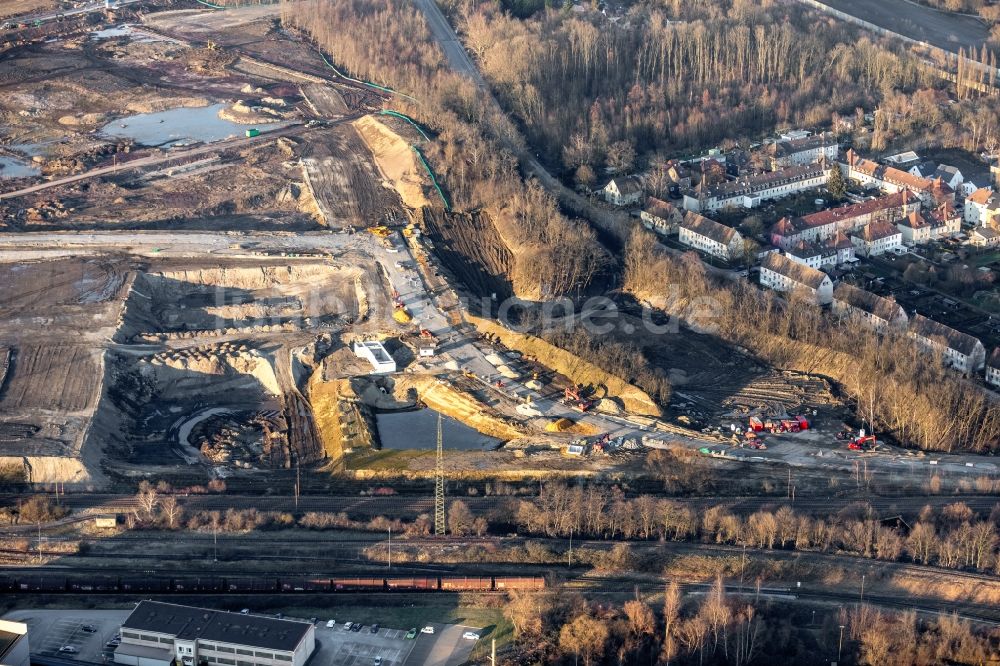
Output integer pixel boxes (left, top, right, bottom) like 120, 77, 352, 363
375, 409, 501, 451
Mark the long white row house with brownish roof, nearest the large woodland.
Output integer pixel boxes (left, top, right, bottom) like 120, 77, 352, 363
684, 164, 830, 212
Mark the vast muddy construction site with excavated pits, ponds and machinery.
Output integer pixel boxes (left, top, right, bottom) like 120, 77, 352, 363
0, 2, 996, 489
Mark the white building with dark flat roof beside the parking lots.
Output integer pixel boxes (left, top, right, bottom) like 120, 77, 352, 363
115, 601, 316, 666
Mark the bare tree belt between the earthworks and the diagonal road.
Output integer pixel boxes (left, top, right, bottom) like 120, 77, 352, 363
282, 0, 611, 299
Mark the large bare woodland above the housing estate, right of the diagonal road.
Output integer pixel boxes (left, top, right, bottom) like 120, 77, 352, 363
453, 0, 920, 178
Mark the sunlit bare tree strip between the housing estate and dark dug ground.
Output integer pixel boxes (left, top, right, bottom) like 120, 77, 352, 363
624, 229, 1000, 452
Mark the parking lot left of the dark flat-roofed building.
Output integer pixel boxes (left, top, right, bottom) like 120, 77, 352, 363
5, 610, 131, 664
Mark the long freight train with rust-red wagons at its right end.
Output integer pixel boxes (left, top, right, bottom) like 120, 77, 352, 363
0, 573, 545, 594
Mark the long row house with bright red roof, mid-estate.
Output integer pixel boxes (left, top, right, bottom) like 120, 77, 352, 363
770, 190, 920, 249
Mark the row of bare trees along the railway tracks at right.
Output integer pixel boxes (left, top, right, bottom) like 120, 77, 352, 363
514, 483, 1000, 574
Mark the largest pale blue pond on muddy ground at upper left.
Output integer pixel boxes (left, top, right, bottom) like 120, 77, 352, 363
100, 104, 273, 146
